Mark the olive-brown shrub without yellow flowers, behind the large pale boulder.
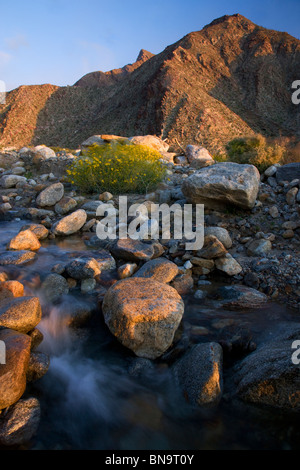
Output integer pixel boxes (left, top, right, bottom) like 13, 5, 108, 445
226, 135, 286, 172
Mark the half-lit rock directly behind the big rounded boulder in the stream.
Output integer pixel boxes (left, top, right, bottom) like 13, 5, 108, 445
134, 258, 178, 283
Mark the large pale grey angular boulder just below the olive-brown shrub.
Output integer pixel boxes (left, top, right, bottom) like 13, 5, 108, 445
182, 162, 260, 209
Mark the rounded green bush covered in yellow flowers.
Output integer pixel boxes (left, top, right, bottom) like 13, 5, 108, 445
67, 142, 166, 194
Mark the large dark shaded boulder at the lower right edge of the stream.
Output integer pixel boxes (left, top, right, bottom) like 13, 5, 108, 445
233, 323, 300, 411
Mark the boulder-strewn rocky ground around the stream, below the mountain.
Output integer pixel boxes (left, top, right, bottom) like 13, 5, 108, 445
0, 136, 300, 445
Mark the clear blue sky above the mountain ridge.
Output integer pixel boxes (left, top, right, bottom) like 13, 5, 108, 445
0, 0, 300, 90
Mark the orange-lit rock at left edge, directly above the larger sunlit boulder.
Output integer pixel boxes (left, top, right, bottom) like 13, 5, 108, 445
0, 297, 42, 333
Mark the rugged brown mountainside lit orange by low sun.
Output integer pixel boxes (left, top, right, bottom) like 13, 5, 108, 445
0, 15, 300, 153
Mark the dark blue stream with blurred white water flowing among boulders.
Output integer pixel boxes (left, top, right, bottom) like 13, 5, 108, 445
0, 221, 300, 450
